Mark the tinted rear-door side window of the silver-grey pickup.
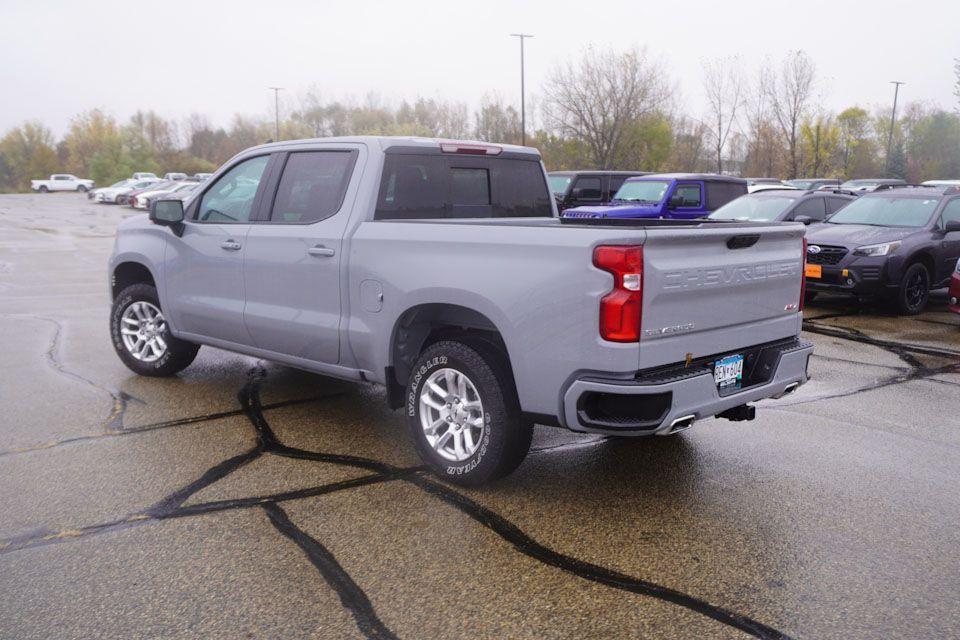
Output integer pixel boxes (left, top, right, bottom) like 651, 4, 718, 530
270, 151, 357, 224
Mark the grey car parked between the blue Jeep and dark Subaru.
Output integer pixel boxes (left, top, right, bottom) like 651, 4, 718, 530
709, 188, 856, 224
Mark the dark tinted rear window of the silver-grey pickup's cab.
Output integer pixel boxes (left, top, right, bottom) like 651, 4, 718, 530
375, 154, 553, 220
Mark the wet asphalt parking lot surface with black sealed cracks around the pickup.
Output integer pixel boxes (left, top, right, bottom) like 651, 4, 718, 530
0, 194, 960, 639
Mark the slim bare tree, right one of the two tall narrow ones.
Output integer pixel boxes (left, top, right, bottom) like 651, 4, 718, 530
763, 50, 816, 178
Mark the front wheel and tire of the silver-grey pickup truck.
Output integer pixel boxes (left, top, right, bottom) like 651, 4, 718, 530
110, 284, 200, 376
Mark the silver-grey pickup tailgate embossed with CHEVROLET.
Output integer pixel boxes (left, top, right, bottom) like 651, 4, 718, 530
640, 224, 804, 369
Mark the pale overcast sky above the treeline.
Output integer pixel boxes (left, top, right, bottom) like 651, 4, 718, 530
0, 0, 960, 135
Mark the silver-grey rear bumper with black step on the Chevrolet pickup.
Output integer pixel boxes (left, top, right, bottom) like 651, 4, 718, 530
562, 338, 813, 436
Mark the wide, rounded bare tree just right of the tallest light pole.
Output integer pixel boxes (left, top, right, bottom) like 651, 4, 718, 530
543, 48, 672, 169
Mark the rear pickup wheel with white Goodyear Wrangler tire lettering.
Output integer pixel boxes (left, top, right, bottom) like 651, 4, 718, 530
406, 340, 533, 486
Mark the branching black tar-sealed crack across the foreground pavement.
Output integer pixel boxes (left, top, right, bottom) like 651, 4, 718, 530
0, 365, 789, 640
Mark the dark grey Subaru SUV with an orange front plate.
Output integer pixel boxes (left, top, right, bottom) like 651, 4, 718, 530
806, 187, 960, 315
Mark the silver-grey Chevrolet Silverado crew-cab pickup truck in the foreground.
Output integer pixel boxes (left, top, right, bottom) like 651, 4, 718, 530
109, 137, 812, 484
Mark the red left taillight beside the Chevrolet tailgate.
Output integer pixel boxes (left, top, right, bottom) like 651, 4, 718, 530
593, 245, 643, 342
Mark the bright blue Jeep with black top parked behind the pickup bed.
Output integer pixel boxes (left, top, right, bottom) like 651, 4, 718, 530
563, 173, 747, 220
